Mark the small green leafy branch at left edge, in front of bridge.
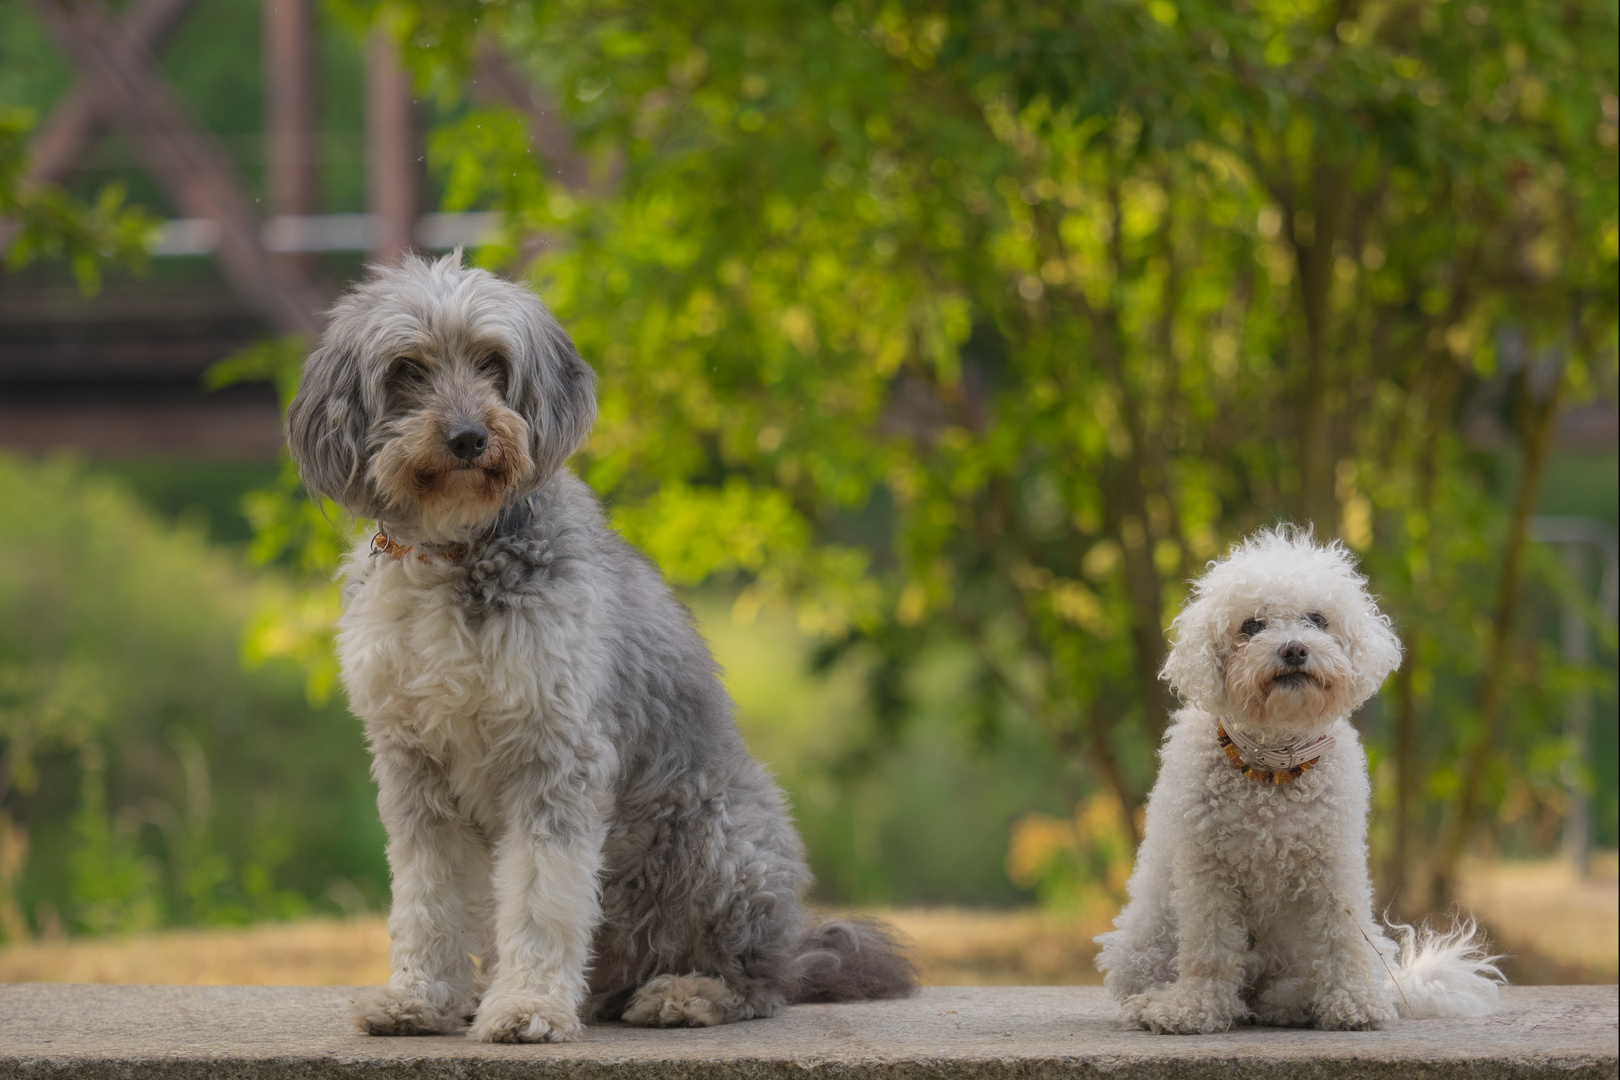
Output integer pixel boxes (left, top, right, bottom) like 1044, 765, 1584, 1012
0, 105, 156, 293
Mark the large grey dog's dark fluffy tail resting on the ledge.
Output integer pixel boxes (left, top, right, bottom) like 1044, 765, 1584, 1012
787, 918, 917, 1004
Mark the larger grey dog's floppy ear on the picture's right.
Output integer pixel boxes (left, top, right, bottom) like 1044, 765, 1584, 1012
514, 298, 596, 484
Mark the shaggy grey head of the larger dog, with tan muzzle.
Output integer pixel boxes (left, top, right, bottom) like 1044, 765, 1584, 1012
287, 251, 596, 544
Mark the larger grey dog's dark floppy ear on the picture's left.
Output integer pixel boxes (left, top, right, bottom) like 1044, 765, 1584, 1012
287, 342, 371, 512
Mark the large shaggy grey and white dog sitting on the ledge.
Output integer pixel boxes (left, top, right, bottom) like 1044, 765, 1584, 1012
288, 253, 915, 1041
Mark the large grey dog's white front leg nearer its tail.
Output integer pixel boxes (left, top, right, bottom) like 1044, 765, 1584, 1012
468, 824, 601, 1043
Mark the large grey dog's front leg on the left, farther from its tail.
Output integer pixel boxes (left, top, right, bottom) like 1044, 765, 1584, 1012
355, 746, 489, 1035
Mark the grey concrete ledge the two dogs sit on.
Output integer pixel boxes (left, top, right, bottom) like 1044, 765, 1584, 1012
0, 983, 1620, 1080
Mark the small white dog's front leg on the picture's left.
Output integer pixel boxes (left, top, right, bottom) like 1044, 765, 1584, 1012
1124, 850, 1249, 1035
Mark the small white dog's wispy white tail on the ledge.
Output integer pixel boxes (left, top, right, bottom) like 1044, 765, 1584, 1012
1388, 918, 1507, 1020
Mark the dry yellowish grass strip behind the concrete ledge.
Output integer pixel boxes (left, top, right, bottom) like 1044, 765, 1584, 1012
0, 852, 1620, 986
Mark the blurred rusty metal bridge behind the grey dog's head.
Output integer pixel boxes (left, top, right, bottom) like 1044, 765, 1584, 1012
0, 0, 588, 458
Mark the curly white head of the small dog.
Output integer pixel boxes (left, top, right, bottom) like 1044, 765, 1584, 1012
1160, 525, 1401, 742
